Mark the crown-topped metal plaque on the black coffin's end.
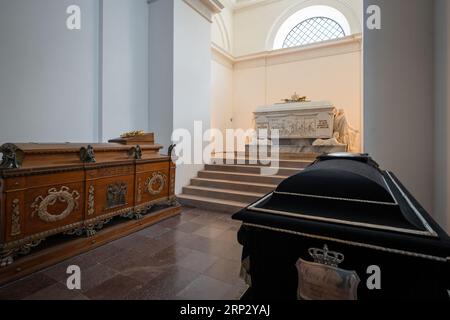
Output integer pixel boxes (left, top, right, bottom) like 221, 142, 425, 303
297, 246, 360, 300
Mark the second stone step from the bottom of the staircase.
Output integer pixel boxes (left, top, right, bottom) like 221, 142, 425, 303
183, 186, 265, 204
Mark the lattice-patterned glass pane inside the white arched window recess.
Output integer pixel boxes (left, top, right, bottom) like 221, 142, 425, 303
283, 17, 345, 48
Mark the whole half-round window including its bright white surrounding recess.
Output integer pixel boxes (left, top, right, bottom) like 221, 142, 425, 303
273, 6, 351, 49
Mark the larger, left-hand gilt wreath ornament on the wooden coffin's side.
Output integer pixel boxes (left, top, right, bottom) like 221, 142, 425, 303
31, 187, 80, 223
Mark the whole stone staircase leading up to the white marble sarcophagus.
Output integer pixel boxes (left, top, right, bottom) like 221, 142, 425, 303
178, 158, 311, 213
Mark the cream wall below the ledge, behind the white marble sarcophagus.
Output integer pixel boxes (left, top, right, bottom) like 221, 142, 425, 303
233, 38, 362, 141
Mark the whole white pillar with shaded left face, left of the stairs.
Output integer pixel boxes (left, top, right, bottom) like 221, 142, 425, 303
149, 0, 223, 193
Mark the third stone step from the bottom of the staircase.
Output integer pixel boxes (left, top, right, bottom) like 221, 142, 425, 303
191, 178, 277, 194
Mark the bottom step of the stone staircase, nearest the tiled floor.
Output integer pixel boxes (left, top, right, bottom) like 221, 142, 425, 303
178, 194, 248, 213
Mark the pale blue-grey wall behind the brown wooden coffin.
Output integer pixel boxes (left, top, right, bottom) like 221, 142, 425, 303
0, 0, 148, 143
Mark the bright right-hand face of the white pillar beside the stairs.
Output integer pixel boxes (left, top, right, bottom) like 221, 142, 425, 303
174, 0, 211, 193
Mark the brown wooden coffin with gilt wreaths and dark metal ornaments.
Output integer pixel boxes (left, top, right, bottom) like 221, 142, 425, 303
0, 134, 179, 282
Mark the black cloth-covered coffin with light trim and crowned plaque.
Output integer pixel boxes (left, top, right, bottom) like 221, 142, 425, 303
233, 154, 450, 300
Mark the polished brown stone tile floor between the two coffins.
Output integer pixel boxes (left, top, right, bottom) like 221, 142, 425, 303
0, 208, 246, 300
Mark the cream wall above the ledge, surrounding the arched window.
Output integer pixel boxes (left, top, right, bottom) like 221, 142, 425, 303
233, 0, 362, 56
